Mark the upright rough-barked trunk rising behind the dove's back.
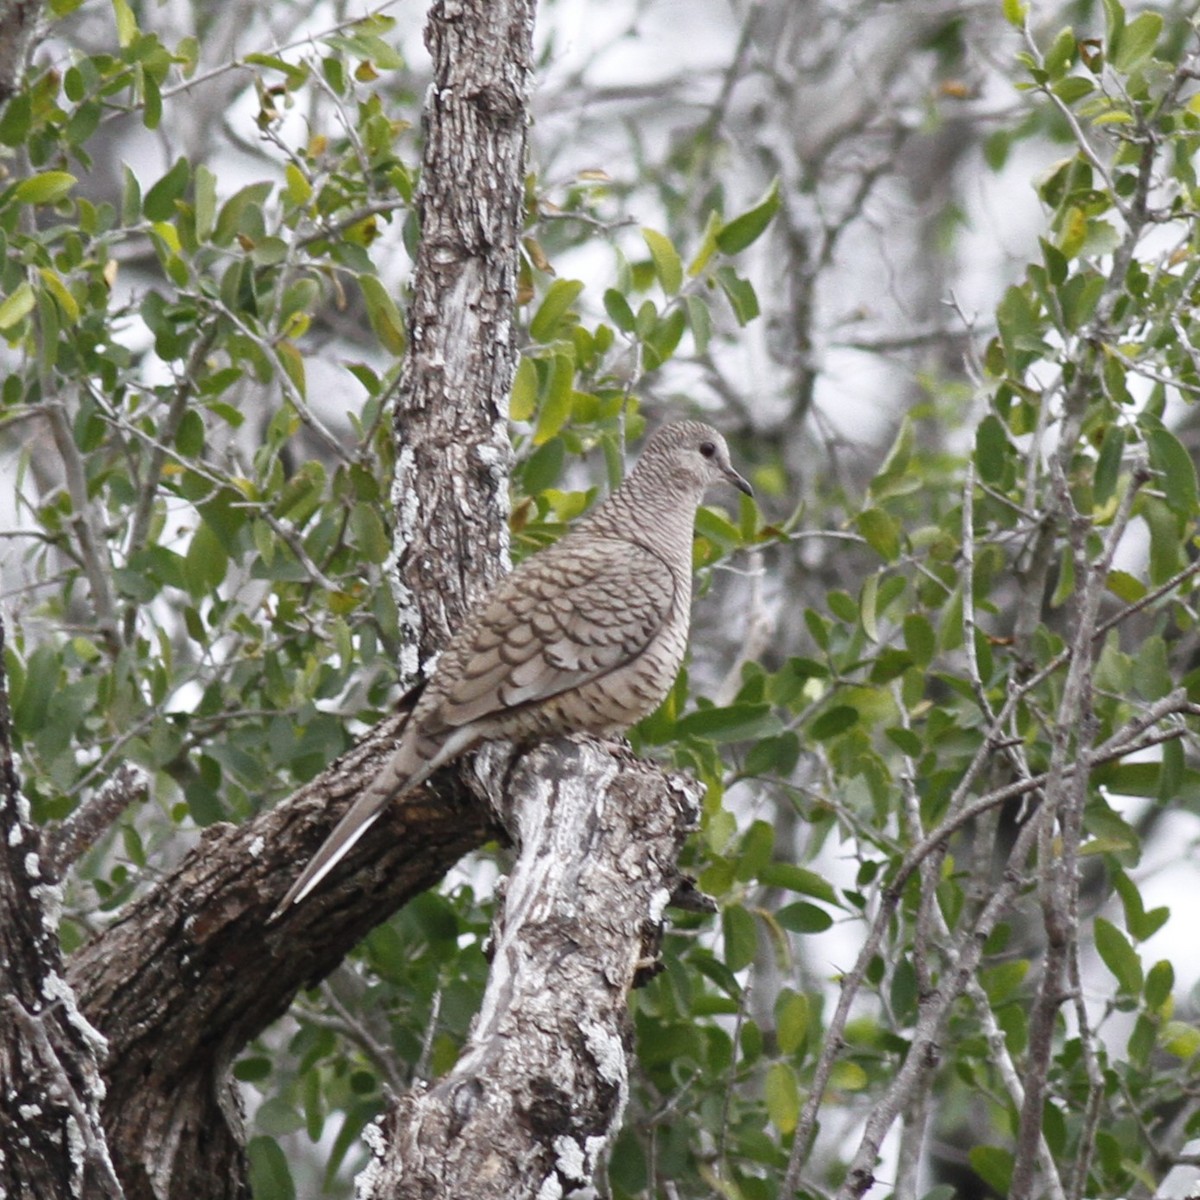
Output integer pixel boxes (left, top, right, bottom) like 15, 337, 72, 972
395, 0, 534, 672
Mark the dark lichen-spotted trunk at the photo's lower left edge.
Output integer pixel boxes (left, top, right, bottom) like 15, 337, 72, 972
0, 620, 121, 1200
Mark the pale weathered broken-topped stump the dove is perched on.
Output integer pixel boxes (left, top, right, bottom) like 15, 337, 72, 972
359, 739, 700, 1200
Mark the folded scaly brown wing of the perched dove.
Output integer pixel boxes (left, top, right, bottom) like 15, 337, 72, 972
421, 536, 677, 732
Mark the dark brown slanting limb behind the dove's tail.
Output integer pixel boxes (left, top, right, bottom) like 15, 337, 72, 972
68, 716, 490, 1200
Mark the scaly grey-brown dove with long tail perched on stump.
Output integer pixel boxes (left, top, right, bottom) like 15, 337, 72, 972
272, 421, 750, 916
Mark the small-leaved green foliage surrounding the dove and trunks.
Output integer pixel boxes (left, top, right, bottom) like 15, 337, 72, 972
0, 0, 1200, 1200
